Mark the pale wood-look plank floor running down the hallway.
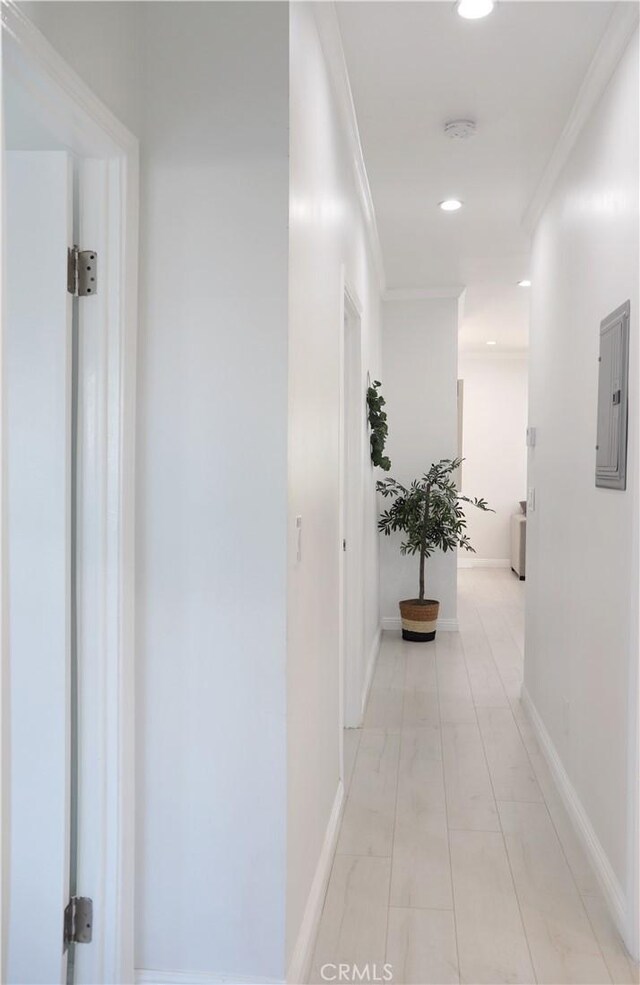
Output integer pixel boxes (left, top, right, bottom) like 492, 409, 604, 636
311, 569, 638, 985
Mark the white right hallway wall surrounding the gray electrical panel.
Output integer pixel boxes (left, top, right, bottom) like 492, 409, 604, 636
525, 33, 640, 952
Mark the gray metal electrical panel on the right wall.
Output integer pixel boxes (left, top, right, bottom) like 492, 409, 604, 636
596, 301, 630, 489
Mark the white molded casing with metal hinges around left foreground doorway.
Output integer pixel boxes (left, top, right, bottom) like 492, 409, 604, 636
2, 2, 138, 983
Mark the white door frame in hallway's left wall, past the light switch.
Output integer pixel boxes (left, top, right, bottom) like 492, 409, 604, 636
338, 269, 364, 780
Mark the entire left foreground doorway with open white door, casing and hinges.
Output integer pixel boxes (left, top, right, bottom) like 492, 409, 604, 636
1, 6, 138, 983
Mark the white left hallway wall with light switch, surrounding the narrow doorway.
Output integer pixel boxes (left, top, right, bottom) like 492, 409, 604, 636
287, 4, 380, 958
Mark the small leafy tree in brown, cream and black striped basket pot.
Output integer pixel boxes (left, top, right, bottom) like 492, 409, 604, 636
377, 458, 493, 642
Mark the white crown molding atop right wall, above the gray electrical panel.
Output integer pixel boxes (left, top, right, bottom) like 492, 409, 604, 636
522, 0, 639, 233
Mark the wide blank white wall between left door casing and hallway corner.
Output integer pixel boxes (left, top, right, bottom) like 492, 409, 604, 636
18, 2, 289, 981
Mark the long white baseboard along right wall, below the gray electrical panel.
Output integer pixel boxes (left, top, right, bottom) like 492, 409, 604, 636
521, 685, 629, 938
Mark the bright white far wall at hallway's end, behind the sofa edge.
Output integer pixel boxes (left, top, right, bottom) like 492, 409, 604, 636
458, 353, 528, 563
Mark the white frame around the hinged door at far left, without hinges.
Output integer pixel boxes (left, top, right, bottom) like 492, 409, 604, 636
0, 0, 139, 982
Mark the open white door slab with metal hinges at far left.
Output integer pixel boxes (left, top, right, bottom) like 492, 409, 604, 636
3, 151, 73, 985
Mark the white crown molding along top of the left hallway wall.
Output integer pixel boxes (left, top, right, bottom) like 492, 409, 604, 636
313, 2, 386, 293
